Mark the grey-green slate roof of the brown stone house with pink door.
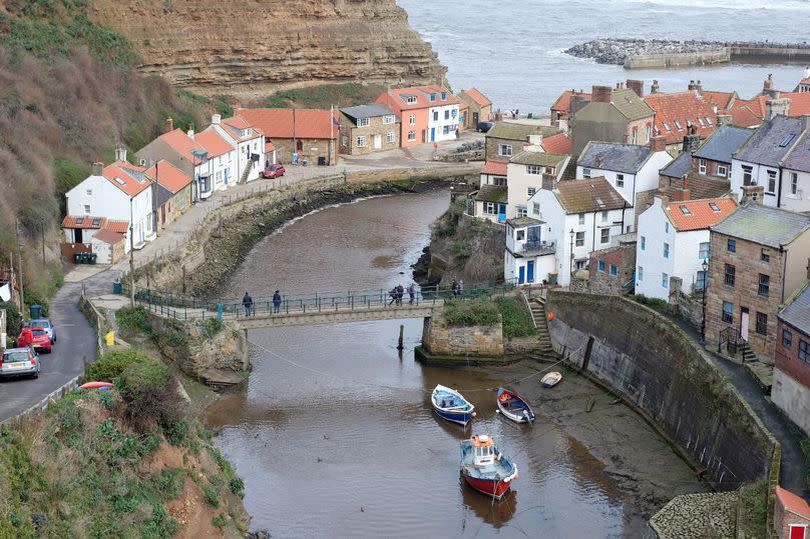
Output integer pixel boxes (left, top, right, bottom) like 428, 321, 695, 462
711, 203, 810, 248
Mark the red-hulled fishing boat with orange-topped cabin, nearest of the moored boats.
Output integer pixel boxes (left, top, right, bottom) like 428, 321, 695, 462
460, 434, 518, 500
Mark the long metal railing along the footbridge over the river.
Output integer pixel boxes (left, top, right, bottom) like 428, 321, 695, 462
135, 282, 515, 320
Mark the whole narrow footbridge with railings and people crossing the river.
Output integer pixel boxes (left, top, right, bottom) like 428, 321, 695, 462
136, 283, 513, 329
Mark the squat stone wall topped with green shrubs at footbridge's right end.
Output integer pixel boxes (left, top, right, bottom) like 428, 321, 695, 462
422, 316, 504, 357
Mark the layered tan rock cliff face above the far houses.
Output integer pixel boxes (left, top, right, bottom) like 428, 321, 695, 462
91, 0, 446, 97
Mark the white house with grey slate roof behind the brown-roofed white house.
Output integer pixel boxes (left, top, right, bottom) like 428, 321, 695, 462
577, 141, 672, 226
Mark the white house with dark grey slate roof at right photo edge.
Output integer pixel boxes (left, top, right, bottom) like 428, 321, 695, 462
731, 115, 810, 211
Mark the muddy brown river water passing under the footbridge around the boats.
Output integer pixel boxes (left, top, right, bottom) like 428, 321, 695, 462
208, 191, 702, 537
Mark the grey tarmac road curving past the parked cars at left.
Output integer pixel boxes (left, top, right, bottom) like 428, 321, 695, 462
0, 283, 96, 421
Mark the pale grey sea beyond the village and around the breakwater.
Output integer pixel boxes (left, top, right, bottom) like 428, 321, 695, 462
397, 0, 810, 114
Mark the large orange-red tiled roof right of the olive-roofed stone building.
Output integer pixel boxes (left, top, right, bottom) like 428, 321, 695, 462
644, 92, 717, 144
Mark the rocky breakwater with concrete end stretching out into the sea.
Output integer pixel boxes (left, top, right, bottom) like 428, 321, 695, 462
565, 38, 810, 69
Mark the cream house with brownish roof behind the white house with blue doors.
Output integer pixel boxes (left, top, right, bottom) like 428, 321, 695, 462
506, 145, 571, 219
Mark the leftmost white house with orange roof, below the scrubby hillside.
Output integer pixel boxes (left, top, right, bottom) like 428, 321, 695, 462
65, 148, 157, 249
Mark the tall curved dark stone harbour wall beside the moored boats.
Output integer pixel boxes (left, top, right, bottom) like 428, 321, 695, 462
547, 290, 779, 490
